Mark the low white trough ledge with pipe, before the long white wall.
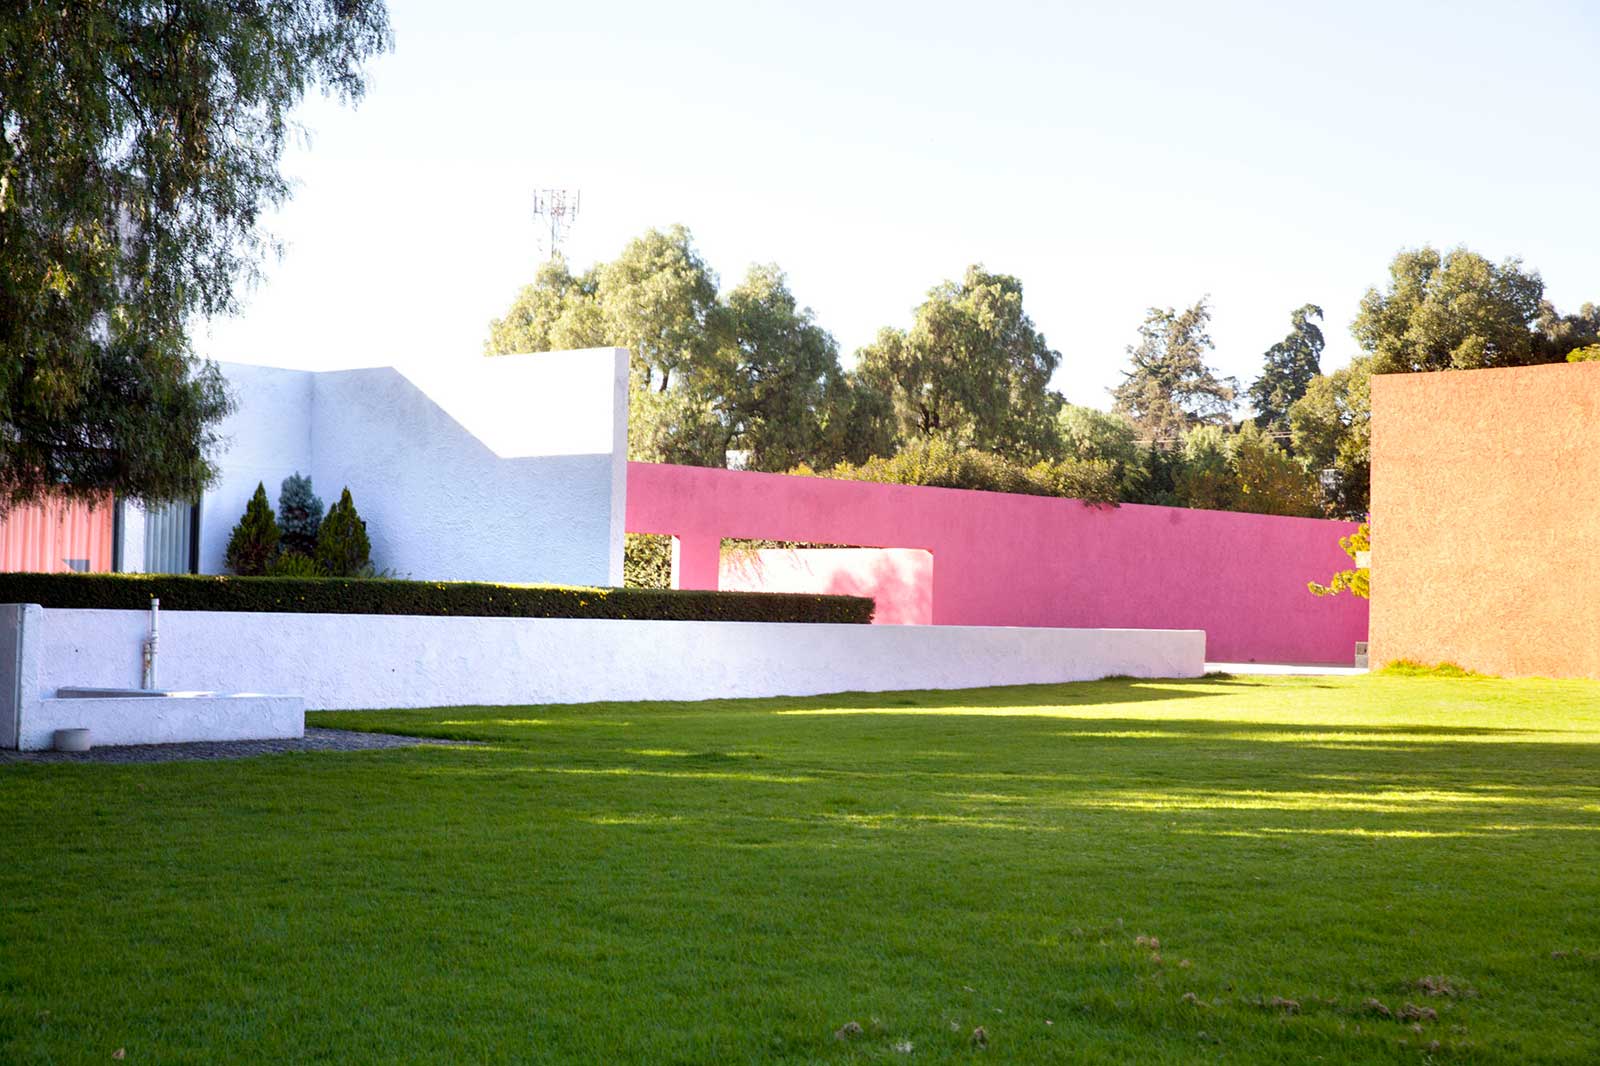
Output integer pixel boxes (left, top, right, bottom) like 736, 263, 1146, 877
19, 693, 306, 751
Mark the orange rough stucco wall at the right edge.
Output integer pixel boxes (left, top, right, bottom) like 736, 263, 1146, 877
1371, 356, 1600, 677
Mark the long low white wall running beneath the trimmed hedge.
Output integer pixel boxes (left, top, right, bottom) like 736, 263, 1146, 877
0, 607, 1205, 729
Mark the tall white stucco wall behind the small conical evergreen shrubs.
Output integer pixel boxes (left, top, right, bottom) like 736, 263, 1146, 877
200, 349, 627, 584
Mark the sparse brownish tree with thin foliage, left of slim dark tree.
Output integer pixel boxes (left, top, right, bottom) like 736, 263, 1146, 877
1112, 299, 1238, 448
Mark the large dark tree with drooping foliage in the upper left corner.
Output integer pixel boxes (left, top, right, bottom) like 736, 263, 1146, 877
0, 0, 389, 501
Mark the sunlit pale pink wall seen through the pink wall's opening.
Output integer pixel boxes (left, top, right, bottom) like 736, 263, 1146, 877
717, 547, 933, 626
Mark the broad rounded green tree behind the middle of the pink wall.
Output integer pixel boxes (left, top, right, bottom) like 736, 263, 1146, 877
856, 266, 1061, 458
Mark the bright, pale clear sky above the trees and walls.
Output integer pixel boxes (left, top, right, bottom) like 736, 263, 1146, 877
197, 0, 1600, 407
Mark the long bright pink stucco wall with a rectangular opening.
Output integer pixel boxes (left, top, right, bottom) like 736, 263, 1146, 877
627, 463, 1366, 663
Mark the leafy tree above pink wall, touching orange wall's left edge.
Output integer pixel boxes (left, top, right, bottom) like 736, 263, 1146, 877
1290, 355, 1373, 519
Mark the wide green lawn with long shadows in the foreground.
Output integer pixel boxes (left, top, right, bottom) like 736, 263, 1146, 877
9, 677, 1600, 1064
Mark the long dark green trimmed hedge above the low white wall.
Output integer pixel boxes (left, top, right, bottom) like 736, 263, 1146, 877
0, 573, 874, 624
